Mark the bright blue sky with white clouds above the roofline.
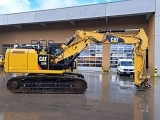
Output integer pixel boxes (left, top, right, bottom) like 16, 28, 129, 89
0, 0, 120, 14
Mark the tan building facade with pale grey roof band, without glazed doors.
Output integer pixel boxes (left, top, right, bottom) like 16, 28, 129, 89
0, 0, 160, 75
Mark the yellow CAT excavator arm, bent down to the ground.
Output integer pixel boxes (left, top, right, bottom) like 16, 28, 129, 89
53, 28, 150, 90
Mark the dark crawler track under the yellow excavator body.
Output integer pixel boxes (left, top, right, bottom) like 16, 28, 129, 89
6, 73, 87, 94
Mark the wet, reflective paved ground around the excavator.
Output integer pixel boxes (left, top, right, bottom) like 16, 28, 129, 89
0, 70, 160, 120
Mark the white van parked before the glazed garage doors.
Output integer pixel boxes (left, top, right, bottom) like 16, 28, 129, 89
117, 59, 134, 75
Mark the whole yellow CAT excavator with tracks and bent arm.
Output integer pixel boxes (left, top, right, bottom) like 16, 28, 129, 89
5, 28, 151, 94
